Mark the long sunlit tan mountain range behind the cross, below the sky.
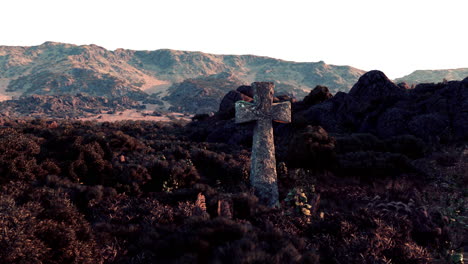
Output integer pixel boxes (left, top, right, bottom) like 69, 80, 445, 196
0, 42, 364, 112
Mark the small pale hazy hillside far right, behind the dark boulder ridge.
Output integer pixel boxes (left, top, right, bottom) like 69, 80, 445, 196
395, 68, 468, 84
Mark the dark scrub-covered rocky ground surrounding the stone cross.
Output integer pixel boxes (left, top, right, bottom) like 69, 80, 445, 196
0, 71, 468, 264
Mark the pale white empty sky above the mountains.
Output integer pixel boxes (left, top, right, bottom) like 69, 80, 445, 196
0, 0, 468, 78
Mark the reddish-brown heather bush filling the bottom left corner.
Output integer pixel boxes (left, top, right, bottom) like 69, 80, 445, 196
0, 182, 102, 263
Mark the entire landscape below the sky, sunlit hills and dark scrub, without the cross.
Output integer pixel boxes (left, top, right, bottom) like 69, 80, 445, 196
0, 42, 468, 264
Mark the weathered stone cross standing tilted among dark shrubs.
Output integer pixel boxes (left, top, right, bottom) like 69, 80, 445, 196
236, 82, 291, 207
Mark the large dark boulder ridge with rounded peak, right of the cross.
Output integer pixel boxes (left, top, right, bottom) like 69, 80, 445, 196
296, 71, 468, 141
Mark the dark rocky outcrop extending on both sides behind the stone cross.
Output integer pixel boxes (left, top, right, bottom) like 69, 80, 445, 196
194, 71, 468, 155
